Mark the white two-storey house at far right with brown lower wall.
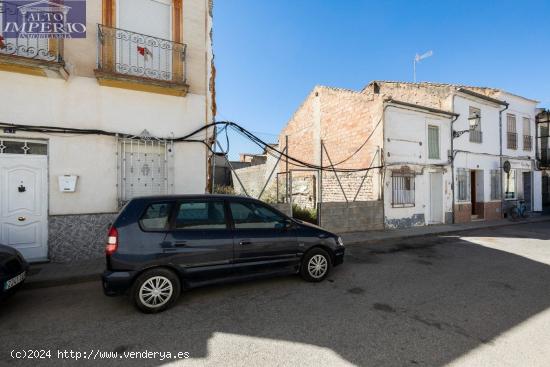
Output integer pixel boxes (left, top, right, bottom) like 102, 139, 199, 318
363, 81, 541, 223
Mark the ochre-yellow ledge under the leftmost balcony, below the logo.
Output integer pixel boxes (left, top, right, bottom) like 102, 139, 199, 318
0, 54, 69, 80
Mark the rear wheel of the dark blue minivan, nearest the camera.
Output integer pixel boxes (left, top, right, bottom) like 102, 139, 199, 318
132, 269, 181, 313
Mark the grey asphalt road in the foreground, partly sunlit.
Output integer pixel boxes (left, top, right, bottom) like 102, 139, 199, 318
0, 222, 550, 367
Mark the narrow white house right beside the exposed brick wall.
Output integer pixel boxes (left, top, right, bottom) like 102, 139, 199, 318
383, 100, 457, 228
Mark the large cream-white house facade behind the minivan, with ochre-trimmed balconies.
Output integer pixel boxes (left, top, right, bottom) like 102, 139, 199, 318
0, 0, 215, 261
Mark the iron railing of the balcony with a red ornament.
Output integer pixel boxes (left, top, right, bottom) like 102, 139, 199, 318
97, 24, 186, 84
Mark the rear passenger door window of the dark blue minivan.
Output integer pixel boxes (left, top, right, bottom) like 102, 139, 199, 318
174, 201, 227, 229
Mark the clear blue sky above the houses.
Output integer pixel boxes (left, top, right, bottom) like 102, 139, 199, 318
214, 0, 550, 158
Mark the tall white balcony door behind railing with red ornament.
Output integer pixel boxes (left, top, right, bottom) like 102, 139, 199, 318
115, 0, 173, 80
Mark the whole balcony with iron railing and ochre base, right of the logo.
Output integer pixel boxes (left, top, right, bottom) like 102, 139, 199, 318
95, 24, 189, 96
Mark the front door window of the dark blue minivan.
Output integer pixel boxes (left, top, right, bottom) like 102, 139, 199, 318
230, 202, 285, 229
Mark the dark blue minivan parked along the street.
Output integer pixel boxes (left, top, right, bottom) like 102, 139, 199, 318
102, 195, 344, 312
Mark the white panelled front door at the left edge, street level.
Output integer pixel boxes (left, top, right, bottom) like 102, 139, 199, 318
0, 154, 48, 262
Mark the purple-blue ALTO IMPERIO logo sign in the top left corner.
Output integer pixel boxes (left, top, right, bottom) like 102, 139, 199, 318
0, 0, 86, 38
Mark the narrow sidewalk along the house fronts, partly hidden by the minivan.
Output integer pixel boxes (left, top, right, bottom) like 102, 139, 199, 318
24, 216, 550, 289
